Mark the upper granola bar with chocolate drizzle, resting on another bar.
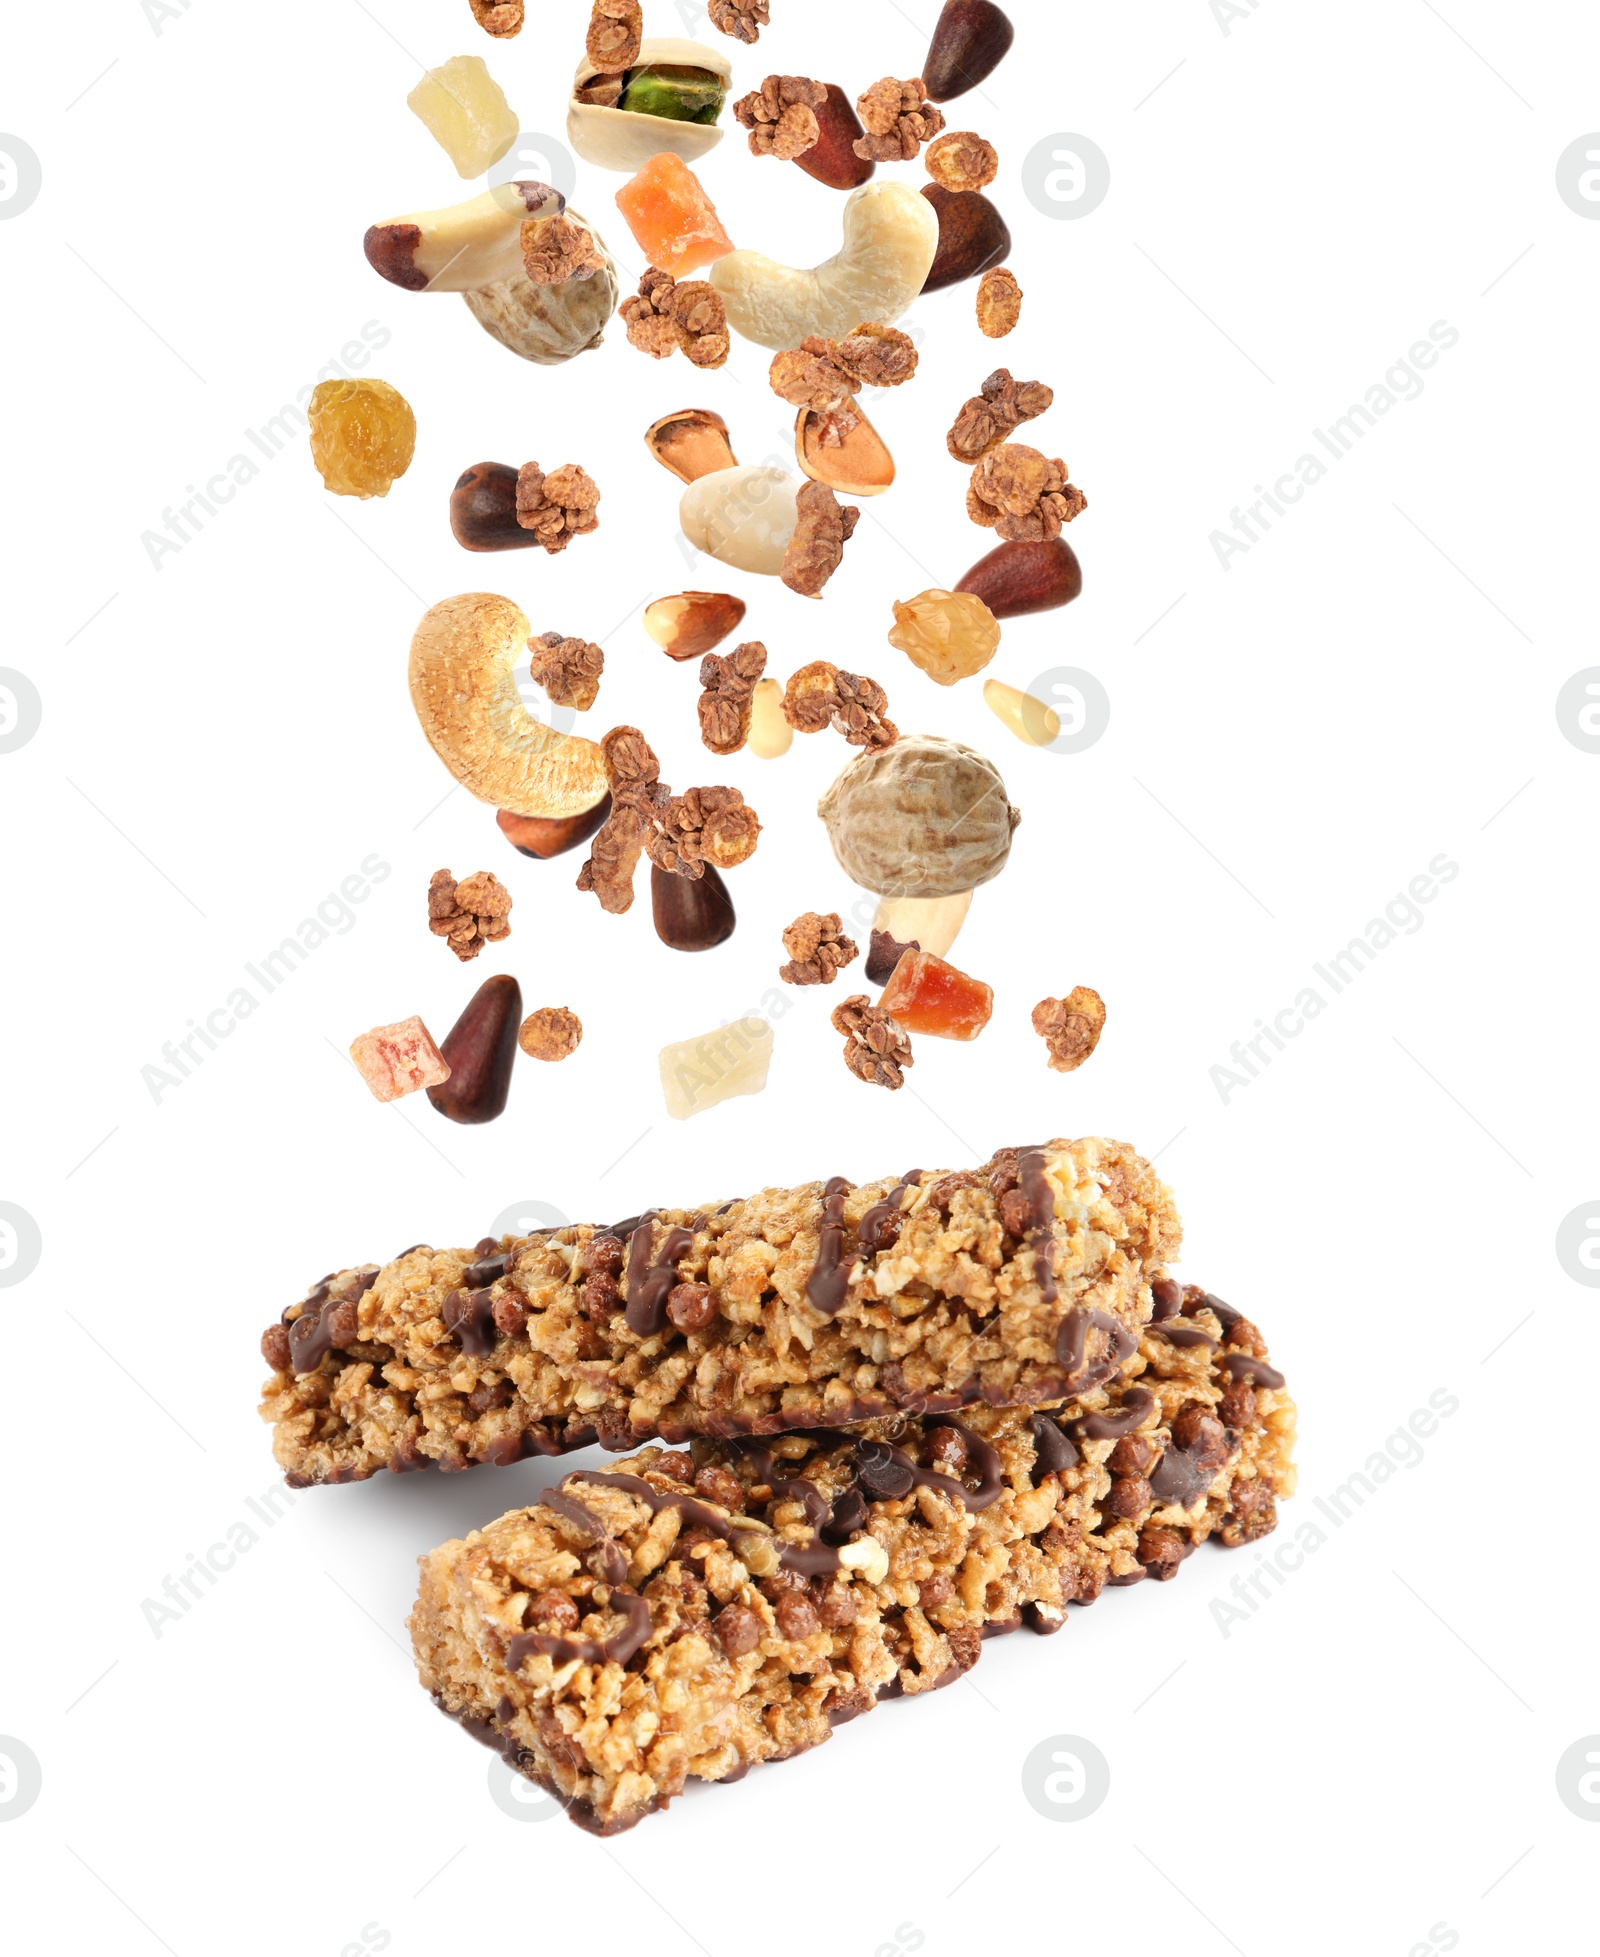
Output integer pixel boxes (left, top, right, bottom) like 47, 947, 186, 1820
262, 1139, 1179, 1487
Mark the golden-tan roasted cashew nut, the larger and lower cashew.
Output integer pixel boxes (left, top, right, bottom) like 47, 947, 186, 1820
411, 591, 608, 816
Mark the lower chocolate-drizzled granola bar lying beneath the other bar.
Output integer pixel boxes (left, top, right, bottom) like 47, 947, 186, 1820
411, 1284, 1295, 1834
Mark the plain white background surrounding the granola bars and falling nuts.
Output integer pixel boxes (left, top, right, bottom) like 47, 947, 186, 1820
0, 0, 1600, 1957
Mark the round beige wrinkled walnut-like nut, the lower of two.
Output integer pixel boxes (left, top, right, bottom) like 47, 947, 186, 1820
818, 734, 1021, 900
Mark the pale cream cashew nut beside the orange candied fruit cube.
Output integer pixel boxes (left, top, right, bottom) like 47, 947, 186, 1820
706, 180, 939, 348
